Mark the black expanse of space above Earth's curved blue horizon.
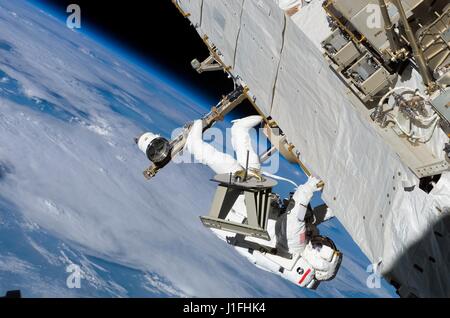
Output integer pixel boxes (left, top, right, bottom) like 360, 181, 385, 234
37, 0, 237, 101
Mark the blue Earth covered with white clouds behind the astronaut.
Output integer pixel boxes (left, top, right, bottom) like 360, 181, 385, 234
0, 0, 395, 297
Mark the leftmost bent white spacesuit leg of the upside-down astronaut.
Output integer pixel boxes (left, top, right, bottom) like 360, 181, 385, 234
185, 120, 242, 174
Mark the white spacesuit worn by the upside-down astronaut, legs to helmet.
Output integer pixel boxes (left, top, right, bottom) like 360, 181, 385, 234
185, 116, 341, 288
